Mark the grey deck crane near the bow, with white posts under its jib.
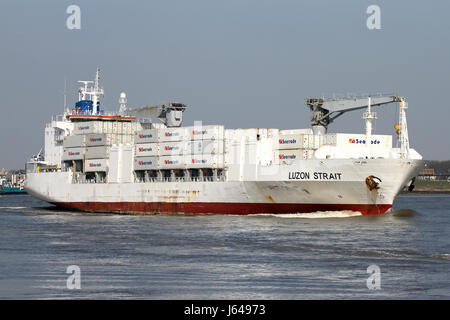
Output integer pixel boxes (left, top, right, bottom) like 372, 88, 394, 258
306, 95, 409, 158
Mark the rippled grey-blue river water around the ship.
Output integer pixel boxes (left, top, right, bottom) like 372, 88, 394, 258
0, 193, 450, 300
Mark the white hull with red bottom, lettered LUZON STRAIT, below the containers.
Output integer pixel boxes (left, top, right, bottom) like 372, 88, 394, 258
26, 159, 423, 214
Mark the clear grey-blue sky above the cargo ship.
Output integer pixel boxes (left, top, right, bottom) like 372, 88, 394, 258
0, 0, 450, 169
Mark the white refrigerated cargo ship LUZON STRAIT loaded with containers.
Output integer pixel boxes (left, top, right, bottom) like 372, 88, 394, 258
25, 69, 423, 215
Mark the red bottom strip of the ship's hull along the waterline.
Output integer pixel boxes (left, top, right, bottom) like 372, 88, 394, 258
49, 202, 392, 215
